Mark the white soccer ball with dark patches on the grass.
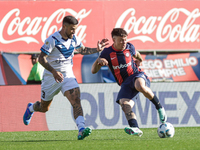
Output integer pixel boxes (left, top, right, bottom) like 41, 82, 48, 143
157, 122, 175, 138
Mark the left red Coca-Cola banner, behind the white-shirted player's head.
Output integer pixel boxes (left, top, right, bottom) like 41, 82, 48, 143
0, 1, 104, 52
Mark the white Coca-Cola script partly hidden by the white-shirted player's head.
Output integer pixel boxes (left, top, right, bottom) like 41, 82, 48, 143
0, 8, 92, 44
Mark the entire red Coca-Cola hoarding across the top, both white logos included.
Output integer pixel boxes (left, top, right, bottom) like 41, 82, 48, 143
0, 1, 200, 52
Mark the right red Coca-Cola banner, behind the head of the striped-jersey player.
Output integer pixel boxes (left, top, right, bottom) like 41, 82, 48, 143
105, 1, 200, 51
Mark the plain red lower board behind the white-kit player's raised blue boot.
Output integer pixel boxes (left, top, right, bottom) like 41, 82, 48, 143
0, 85, 49, 132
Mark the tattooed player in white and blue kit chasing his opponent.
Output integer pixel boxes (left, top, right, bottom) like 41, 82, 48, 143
23, 16, 108, 140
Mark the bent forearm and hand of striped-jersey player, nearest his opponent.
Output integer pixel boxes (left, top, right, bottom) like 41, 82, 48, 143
91, 57, 108, 74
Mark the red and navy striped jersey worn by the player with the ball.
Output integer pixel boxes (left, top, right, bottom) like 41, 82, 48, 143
99, 43, 141, 85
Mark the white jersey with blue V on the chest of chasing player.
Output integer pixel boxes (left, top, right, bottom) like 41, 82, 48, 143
40, 31, 82, 77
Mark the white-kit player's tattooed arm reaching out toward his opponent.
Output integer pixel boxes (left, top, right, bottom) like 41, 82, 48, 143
76, 39, 109, 55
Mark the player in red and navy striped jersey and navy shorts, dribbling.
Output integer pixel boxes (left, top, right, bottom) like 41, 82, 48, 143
91, 28, 167, 136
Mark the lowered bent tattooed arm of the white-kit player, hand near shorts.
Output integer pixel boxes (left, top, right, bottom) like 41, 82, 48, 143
39, 52, 63, 82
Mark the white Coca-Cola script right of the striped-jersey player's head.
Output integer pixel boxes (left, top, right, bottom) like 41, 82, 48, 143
115, 8, 200, 43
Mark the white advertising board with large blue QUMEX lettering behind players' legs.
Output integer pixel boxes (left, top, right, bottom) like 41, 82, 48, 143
46, 82, 200, 130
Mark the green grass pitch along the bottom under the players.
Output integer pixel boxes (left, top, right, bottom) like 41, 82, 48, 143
0, 127, 200, 150
